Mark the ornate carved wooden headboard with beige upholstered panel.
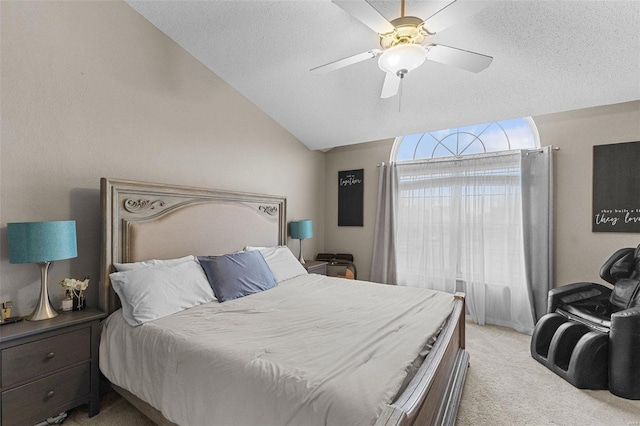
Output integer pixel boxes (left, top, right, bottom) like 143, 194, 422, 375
98, 178, 287, 313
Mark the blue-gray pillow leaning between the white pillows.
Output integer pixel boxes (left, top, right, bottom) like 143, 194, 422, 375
198, 251, 276, 302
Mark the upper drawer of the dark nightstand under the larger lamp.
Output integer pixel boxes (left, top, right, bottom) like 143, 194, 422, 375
1, 327, 91, 386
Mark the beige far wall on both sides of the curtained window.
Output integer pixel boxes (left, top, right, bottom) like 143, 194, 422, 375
325, 101, 640, 286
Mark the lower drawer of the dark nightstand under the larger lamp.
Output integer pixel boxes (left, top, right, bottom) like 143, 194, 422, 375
2, 362, 91, 426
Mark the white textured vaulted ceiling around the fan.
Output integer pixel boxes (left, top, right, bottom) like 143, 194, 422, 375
128, 0, 640, 149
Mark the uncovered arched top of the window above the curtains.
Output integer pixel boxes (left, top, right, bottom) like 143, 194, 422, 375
391, 117, 540, 162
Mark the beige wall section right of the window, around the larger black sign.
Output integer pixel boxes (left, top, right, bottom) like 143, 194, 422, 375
534, 101, 640, 286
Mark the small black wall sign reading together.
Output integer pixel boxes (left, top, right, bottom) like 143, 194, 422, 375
338, 169, 364, 226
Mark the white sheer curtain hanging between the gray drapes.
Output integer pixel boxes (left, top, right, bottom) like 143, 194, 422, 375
395, 151, 535, 333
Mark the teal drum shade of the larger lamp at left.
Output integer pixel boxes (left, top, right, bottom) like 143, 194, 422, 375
7, 220, 78, 263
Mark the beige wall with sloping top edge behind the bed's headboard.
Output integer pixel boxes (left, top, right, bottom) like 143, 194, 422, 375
0, 1, 325, 315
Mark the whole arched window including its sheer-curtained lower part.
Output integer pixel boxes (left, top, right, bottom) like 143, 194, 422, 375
381, 118, 550, 333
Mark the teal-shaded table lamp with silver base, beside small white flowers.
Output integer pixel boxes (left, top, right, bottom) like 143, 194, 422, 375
7, 220, 78, 321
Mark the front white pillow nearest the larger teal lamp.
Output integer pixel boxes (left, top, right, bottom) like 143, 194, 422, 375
109, 260, 216, 327
